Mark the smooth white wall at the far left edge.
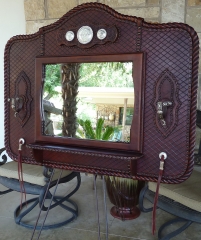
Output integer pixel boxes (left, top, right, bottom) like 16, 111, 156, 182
0, 0, 26, 148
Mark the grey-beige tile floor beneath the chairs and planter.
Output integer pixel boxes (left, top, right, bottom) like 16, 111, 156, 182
0, 174, 201, 240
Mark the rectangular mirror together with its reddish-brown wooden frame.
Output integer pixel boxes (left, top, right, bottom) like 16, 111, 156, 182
35, 53, 144, 154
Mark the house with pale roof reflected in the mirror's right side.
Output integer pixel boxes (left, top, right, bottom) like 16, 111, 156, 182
78, 87, 134, 141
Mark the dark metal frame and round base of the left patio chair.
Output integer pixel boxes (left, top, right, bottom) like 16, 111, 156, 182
0, 148, 81, 230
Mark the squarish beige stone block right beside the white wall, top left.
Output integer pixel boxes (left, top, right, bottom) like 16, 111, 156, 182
24, 0, 45, 20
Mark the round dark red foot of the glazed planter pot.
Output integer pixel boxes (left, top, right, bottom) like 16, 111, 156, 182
110, 206, 140, 220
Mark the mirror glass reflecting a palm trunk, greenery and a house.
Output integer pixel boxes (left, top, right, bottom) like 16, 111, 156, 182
42, 62, 134, 143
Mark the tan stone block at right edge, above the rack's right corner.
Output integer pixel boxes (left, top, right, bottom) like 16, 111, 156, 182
186, 7, 201, 32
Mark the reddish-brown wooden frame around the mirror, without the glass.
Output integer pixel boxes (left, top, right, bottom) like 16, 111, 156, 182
35, 53, 145, 155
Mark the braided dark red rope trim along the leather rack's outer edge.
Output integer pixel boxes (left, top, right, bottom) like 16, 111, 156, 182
4, 3, 199, 183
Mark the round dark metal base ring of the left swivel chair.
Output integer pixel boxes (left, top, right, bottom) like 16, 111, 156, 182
14, 196, 78, 230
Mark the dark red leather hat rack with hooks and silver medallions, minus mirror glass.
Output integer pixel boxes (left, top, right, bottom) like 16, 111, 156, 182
5, 3, 199, 183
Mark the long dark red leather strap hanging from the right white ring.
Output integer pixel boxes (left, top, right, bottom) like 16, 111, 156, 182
152, 155, 164, 235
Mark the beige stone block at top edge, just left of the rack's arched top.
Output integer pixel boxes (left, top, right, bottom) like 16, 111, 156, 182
47, 0, 78, 18
